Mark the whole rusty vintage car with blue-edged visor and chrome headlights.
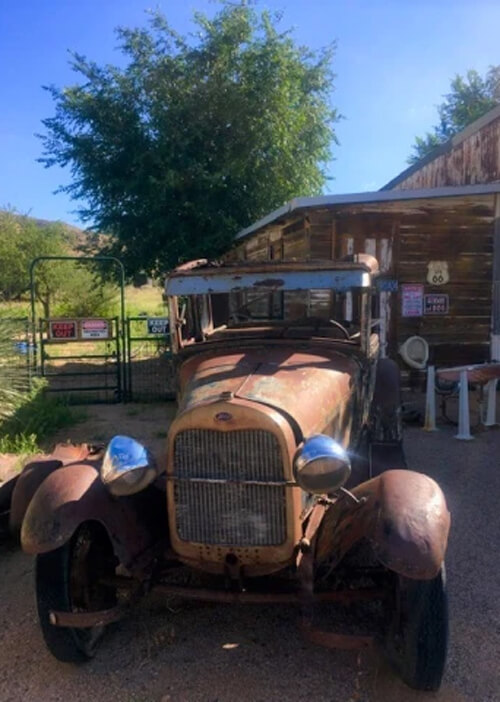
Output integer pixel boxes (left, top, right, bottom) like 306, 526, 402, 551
10, 255, 450, 690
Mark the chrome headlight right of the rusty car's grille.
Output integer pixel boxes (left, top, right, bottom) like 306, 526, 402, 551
293, 434, 351, 495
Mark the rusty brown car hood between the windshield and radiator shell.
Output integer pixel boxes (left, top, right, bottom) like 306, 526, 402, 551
180, 347, 360, 443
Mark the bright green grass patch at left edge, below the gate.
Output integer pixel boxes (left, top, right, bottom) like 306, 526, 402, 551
0, 381, 86, 454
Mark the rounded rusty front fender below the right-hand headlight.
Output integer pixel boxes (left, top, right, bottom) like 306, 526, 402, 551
316, 470, 450, 580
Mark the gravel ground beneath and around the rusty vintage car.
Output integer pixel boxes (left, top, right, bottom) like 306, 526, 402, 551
0, 405, 500, 702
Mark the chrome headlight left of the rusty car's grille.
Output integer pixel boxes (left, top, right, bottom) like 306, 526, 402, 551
101, 436, 157, 497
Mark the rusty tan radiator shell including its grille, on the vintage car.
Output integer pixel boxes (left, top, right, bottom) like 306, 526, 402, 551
167, 398, 302, 575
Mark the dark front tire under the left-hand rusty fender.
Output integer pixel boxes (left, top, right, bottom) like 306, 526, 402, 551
35, 522, 116, 663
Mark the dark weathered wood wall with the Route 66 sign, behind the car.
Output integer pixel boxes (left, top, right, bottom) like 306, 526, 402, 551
228, 195, 494, 366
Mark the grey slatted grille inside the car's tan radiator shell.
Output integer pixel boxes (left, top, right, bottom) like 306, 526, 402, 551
174, 429, 286, 546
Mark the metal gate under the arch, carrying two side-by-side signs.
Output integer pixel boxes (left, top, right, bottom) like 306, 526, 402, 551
39, 317, 121, 403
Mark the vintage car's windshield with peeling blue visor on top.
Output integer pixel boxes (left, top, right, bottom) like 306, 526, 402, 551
166, 264, 371, 346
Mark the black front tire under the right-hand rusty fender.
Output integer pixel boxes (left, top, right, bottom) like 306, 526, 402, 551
387, 565, 448, 691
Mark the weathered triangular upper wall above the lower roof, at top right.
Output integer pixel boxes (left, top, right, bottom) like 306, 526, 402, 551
386, 117, 500, 190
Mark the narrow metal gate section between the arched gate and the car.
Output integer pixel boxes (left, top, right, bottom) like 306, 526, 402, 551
126, 317, 175, 402
